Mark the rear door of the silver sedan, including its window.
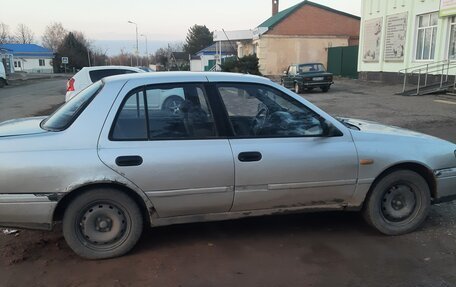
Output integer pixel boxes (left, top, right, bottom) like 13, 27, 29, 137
98, 83, 234, 217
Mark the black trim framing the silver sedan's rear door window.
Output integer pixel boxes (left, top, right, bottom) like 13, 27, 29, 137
108, 82, 226, 142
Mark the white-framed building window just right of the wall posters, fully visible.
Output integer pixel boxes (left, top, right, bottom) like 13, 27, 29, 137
415, 12, 439, 60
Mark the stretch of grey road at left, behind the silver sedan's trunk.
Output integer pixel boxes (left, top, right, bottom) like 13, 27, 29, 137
0, 78, 66, 122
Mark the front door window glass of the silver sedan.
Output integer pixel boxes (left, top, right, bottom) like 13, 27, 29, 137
218, 84, 323, 137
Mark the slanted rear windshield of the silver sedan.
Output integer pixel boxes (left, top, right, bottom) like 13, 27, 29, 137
41, 81, 103, 131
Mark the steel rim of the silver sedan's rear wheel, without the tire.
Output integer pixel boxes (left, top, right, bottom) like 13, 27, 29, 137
76, 201, 131, 251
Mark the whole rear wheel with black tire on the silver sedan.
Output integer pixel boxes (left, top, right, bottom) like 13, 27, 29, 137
63, 188, 143, 259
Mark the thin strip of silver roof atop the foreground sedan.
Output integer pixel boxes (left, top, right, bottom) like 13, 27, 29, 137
103, 72, 271, 83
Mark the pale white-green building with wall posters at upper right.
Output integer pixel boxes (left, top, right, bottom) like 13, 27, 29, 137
358, 0, 456, 82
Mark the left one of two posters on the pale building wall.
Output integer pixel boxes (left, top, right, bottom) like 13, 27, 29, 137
363, 17, 383, 63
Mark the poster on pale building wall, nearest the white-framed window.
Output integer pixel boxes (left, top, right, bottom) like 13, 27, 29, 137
385, 12, 408, 62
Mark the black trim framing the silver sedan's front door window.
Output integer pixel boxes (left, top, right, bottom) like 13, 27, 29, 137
214, 81, 344, 139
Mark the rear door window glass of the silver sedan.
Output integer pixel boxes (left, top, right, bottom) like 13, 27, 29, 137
111, 84, 217, 140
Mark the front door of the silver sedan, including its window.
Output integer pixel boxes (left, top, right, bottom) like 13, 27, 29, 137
217, 83, 358, 211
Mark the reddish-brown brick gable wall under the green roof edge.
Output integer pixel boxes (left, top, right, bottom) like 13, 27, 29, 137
267, 5, 360, 40
